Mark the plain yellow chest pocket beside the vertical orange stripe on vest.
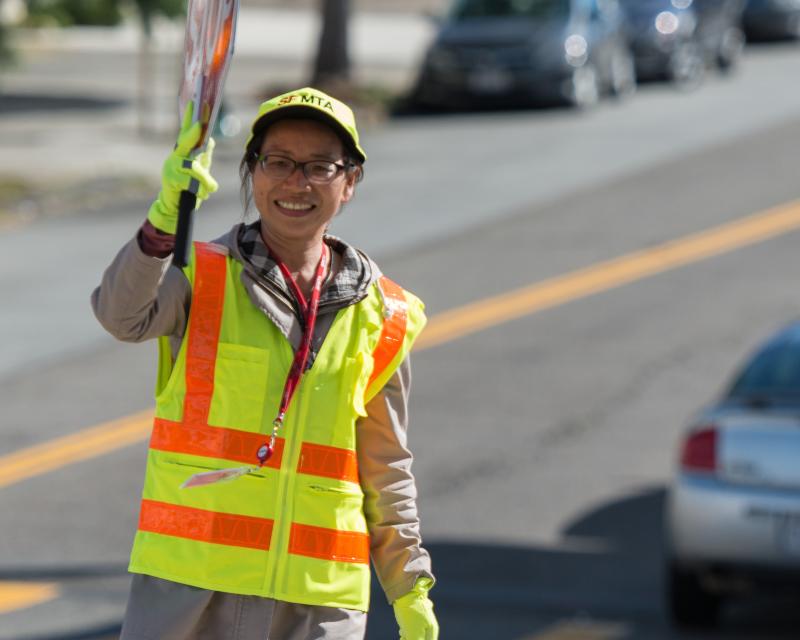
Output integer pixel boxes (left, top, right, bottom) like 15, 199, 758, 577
208, 342, 269, 432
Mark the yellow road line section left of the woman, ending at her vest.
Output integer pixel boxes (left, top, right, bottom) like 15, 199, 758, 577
0, 410, 153, 488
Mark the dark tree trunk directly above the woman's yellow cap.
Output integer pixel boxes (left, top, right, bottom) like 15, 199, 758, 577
312, 0, 350, 86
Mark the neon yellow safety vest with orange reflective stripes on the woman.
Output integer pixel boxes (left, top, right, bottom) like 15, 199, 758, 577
129, 243, 425, 611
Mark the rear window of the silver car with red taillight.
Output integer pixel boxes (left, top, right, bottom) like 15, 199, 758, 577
728, 343, 800, 398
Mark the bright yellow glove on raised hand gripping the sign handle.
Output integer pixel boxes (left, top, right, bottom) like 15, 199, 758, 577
147, 102, 218, 235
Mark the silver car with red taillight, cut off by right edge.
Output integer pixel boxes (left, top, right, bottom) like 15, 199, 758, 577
665, 322, 800, 626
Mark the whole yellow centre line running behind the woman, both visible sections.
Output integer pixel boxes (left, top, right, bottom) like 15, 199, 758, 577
0, 201, 800, 488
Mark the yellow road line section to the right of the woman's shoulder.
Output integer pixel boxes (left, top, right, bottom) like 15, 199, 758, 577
415, 201, 800, 349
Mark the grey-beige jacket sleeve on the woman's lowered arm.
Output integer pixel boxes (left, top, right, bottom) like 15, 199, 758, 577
357, 358, 433, 603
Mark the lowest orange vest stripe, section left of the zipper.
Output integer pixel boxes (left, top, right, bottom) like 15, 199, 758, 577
139, 500, 273, 551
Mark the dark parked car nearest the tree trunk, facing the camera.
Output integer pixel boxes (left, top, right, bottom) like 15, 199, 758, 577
412, 0, 636, 108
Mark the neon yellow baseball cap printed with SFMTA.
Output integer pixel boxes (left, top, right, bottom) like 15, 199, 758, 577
245, 87, 367, 162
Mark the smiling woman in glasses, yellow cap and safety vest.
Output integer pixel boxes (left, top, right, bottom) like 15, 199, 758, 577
92, 88, 438, 640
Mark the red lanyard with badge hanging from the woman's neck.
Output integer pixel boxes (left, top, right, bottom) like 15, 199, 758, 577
181, 243, 330, 488
